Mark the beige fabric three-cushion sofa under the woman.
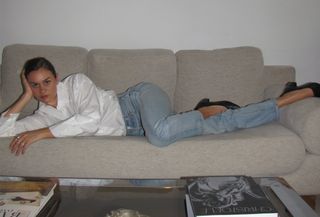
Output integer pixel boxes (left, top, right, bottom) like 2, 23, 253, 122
0, 44, 320, 195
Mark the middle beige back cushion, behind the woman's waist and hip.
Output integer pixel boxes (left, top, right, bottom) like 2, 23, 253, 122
88, 49, 177, 102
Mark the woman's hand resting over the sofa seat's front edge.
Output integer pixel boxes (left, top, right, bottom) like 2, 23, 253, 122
10, 128, 53, 156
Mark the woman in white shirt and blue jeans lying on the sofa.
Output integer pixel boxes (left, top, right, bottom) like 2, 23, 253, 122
0, 57, 320, 155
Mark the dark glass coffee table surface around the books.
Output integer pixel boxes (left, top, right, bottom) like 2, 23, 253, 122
0, 176, 319, 217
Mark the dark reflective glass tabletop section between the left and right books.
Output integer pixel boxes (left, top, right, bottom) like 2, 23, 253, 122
55, 179, 186, 217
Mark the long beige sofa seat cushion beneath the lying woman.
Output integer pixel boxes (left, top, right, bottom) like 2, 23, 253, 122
0, 123, 305, 178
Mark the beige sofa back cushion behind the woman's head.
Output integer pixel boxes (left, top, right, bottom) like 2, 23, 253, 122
1, 44, 88, 116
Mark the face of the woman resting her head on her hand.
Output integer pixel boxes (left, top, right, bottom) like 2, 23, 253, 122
27, 68, 58, 107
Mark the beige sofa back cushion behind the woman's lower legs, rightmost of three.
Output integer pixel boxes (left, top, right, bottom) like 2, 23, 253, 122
175, 47, 264, 112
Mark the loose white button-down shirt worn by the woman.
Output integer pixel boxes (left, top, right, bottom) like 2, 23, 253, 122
0, 74, 126, 137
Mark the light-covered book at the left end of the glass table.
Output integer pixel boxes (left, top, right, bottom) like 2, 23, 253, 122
0, 180, 59, 217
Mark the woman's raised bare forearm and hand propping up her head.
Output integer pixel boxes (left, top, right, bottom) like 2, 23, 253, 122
4, 72, 33, 117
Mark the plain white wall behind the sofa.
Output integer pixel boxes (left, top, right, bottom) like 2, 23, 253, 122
0, 0, 320, 83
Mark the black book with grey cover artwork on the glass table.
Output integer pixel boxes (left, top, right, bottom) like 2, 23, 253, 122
185, 176, 278, 217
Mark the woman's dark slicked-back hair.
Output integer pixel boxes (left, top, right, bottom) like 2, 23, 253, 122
23, 57, 57, 78
